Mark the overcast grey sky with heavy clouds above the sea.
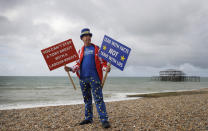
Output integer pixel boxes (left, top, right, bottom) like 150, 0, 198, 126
0, 0, 208, 76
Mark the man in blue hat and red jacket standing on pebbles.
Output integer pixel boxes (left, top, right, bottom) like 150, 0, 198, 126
64, 28, 110, 128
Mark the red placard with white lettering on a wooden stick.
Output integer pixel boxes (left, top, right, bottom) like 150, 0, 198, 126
41, 39, 79, 71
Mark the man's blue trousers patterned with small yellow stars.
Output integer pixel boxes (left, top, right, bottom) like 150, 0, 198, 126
80, 77, 108, 122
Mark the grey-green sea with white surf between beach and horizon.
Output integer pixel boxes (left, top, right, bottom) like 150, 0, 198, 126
0, 76, 208, 110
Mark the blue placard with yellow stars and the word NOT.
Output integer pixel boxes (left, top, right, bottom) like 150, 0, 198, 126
99, 35, 131, 71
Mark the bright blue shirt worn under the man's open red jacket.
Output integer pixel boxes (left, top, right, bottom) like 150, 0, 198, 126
80, 45, 100, 80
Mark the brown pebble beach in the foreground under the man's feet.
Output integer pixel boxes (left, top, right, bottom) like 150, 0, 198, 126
0, 89, 208, 131
